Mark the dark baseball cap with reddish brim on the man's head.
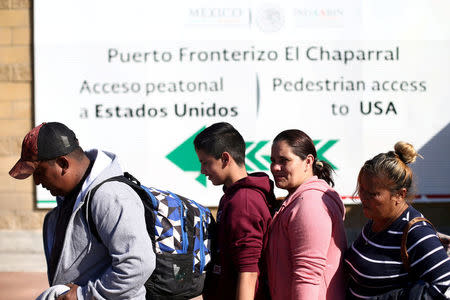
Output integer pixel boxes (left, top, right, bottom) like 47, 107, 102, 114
9, 122, 79, 179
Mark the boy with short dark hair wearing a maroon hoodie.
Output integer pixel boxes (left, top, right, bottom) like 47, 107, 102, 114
194, 123, 275, 300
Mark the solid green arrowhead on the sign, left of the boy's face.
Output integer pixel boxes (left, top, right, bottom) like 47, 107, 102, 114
166, 126, 207, 186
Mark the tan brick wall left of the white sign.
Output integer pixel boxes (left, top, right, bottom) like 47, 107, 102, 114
0, 0, 45, 229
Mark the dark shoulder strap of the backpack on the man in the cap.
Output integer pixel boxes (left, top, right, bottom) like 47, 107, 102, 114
83, 172, 155, 250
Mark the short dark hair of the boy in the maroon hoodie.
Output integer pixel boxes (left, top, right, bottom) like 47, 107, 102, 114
194, 122, 245, 166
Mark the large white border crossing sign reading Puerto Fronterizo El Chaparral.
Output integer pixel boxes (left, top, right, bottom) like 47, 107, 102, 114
34, 0, 450, 208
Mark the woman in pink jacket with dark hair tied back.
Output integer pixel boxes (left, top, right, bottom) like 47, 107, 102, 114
266, 129, 347, 300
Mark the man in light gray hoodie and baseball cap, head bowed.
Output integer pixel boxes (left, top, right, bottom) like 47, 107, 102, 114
9, 122, 155, 299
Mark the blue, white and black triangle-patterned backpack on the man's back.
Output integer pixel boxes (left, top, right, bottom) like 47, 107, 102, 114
85, 172, 215, 299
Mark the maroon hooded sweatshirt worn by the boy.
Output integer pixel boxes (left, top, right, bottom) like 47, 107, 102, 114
204, 173, 275, 300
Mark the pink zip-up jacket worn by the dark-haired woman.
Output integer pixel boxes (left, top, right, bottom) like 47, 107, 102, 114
266, 176, 347, 300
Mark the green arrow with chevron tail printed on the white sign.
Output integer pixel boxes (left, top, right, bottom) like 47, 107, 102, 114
166, 126, 338, 187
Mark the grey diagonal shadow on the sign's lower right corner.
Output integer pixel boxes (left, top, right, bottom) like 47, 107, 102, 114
411, 123, 450, 197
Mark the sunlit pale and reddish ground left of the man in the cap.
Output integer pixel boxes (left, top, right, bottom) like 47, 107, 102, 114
0, 230, 202, 300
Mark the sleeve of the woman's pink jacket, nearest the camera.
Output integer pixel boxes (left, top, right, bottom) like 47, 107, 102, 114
287, 190, 332, 299
